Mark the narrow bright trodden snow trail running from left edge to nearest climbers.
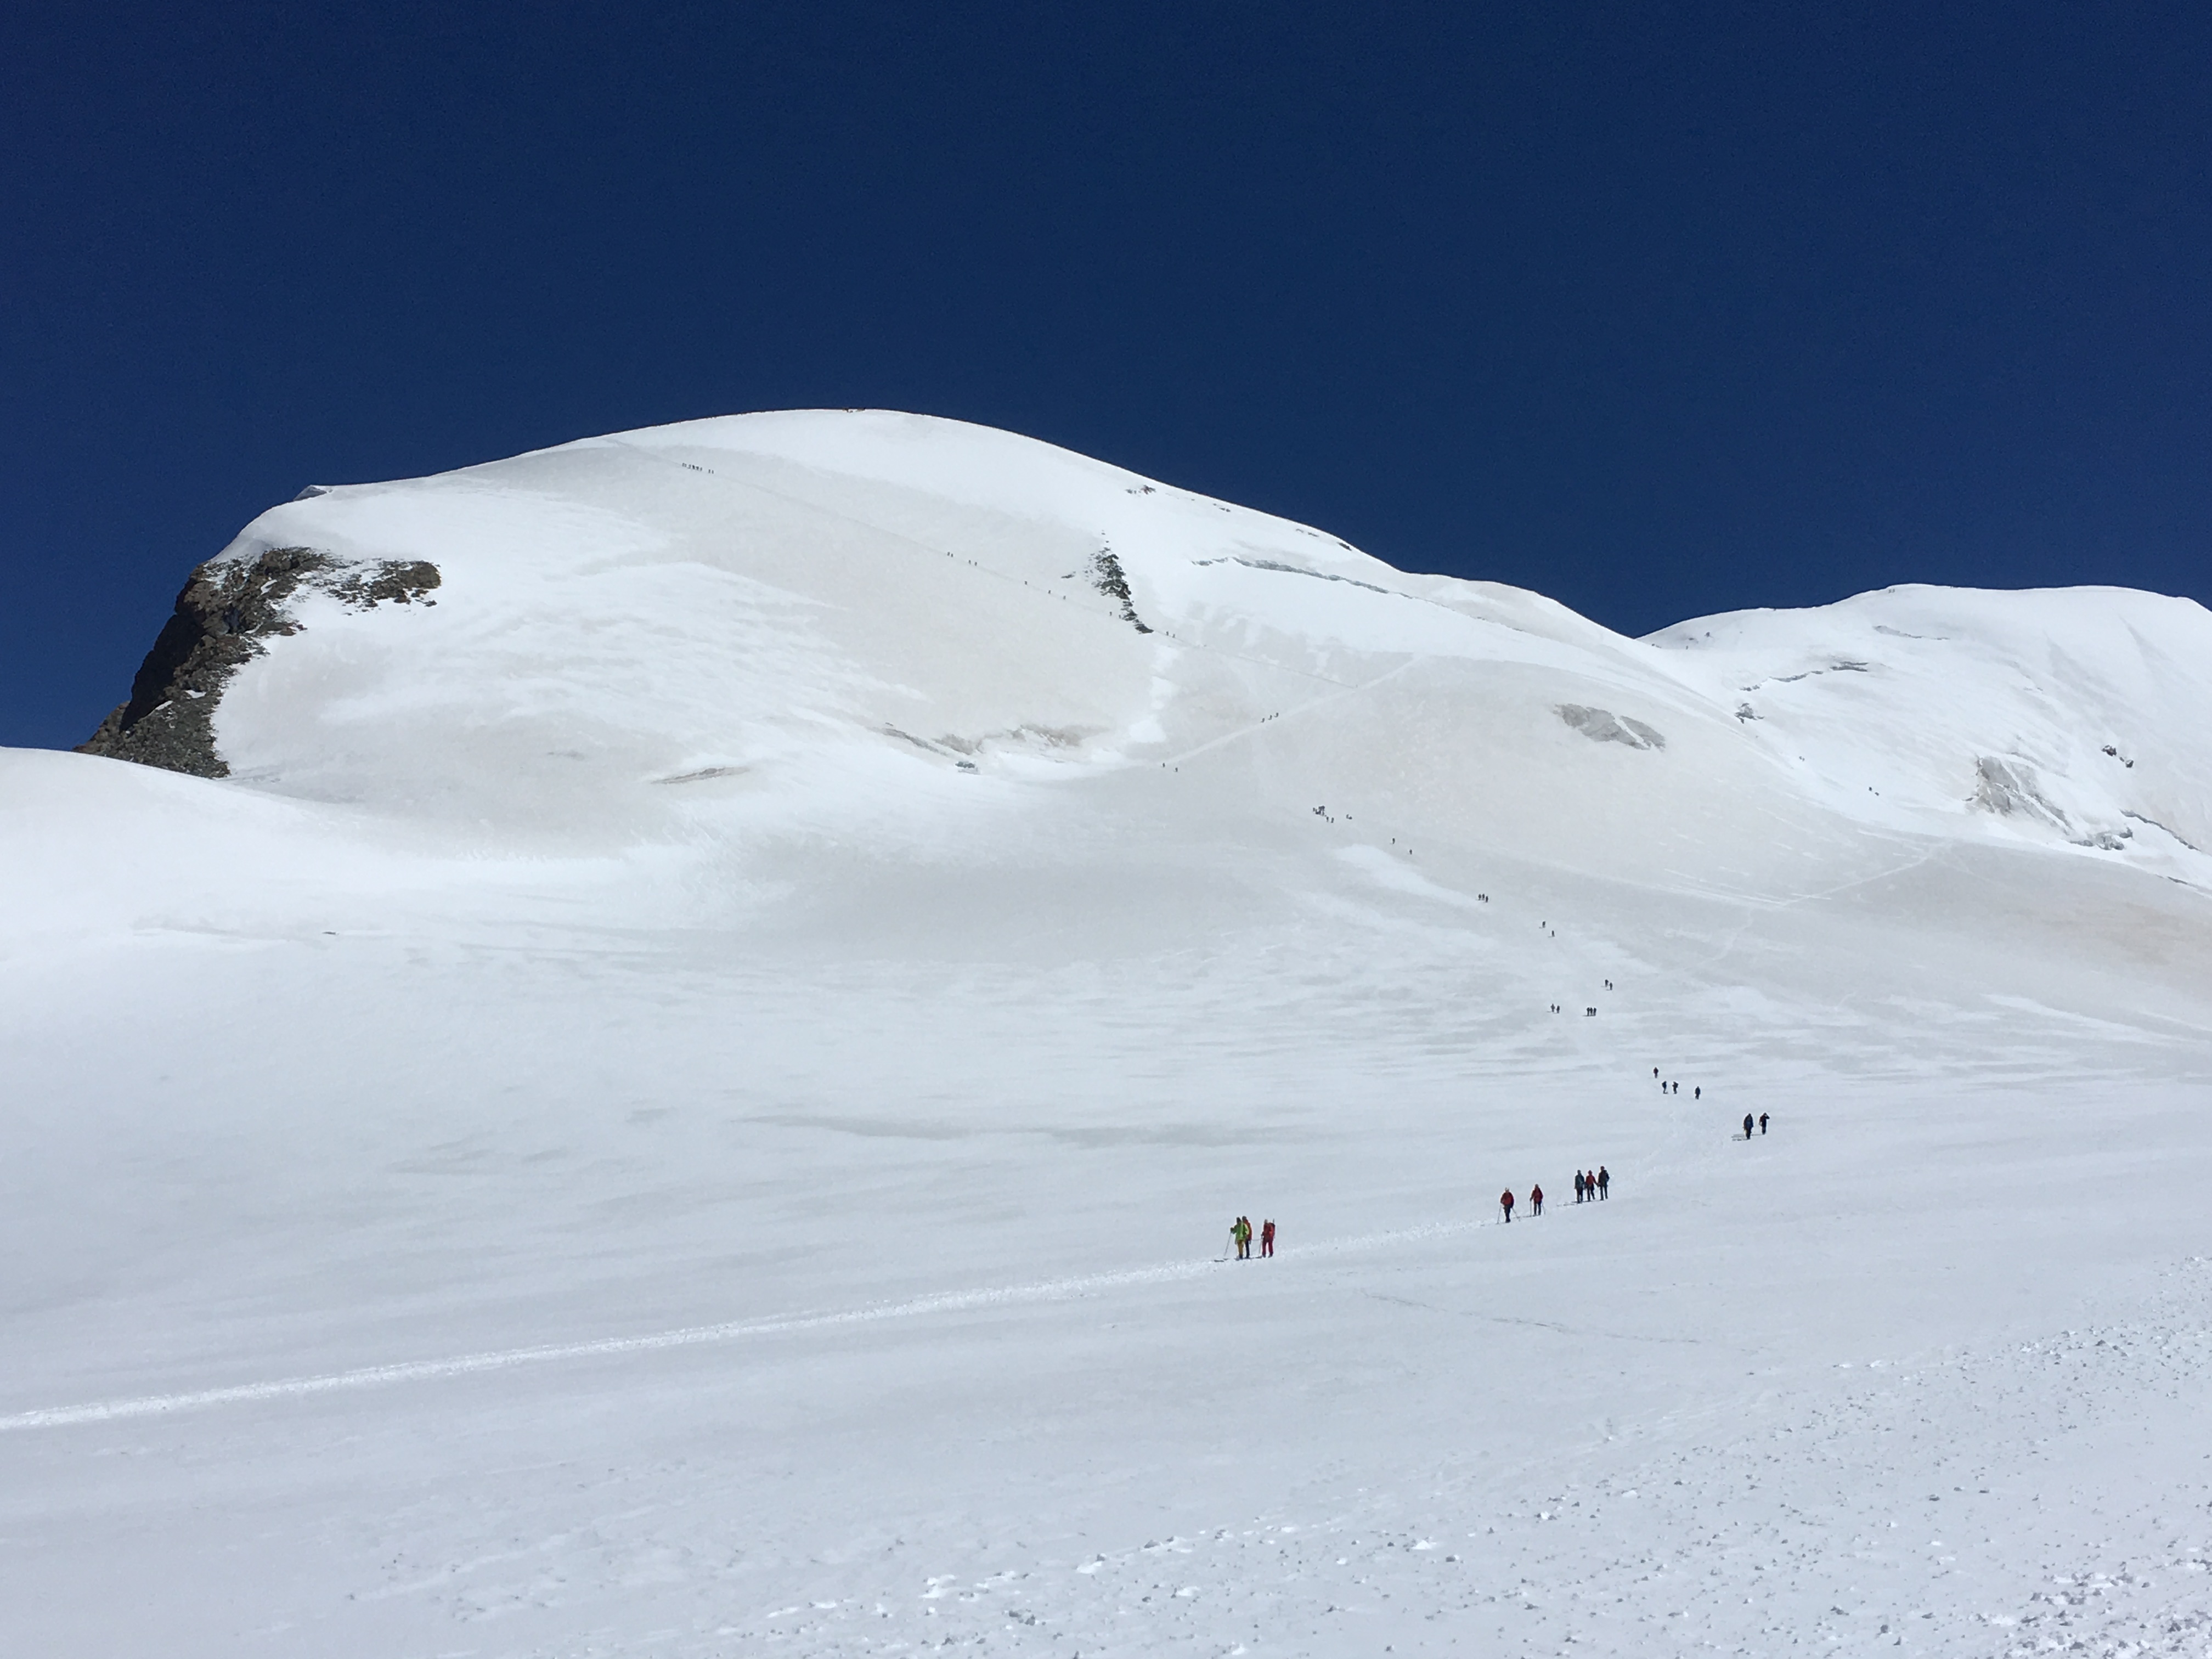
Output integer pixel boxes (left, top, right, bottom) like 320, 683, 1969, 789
0, 1221, 1493, 1434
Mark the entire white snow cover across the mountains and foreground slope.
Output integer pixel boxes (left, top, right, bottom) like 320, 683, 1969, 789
0, 414, 2212, 1659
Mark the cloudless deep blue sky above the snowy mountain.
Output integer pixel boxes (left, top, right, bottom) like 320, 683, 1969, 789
0, 0, 2212, 746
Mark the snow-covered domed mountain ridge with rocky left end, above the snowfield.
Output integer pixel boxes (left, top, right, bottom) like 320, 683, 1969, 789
69, 411, 2212, 898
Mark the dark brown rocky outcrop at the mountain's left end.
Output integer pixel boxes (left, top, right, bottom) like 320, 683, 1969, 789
77, 546, 438, 778
